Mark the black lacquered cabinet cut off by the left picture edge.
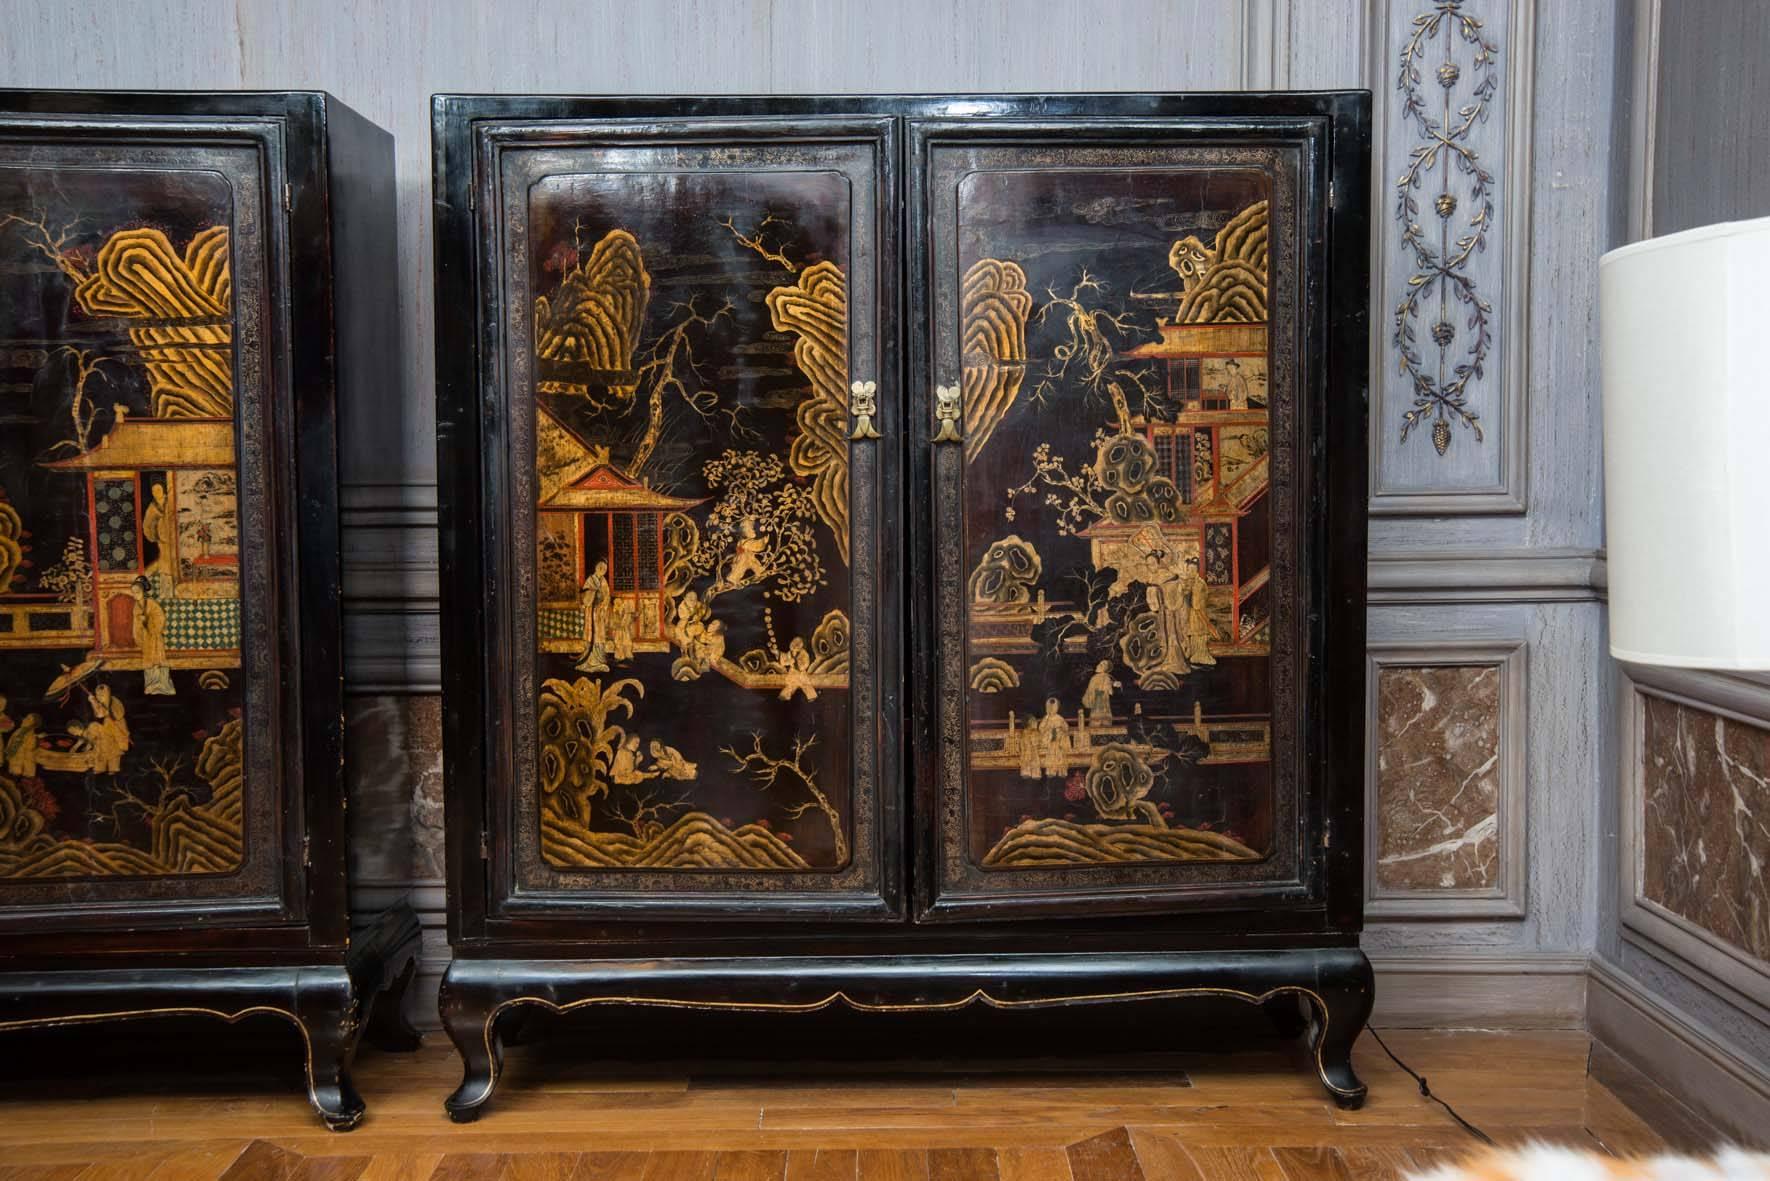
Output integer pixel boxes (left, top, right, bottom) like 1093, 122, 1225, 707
0, 90, 416, 1130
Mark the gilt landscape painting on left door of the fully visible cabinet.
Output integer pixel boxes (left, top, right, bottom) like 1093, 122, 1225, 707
524, 170, 878, 882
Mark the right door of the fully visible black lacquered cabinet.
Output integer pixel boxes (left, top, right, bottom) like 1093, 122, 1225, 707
908, 119, 1338, 921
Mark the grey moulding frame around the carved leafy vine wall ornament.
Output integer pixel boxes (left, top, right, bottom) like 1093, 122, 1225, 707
1365, 0, 1536, 517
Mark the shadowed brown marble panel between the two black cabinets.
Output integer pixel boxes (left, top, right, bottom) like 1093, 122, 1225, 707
345, 694, 443, 882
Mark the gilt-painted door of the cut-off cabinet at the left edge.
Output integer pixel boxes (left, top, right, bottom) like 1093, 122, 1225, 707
0, 113, 307, 951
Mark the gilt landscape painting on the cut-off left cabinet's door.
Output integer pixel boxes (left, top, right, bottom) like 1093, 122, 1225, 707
0, 165, 244, 880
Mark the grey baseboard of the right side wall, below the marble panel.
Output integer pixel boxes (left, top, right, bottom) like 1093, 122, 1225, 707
1586, 960, 1770, 1146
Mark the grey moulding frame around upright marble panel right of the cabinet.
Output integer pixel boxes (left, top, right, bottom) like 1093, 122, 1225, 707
1365, 636, 1529, 919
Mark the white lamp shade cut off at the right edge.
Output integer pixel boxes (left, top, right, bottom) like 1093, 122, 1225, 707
1598, 218, 1770, 669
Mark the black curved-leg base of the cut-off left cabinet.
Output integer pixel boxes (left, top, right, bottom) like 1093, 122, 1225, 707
0, 907, 418, 1131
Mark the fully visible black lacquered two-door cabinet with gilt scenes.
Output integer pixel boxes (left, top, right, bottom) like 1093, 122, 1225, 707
434, 94, 1370, 1117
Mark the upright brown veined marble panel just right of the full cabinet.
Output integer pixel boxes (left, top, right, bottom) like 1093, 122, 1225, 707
1375, 664, 1501, 892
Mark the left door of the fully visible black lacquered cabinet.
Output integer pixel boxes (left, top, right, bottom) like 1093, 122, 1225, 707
439, 110, 903, 938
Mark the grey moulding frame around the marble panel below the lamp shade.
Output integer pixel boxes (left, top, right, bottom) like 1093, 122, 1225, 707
1616, 662, 1770, 1009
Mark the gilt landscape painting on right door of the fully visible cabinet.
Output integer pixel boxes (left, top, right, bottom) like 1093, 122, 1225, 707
955, 168, 1274, 871
